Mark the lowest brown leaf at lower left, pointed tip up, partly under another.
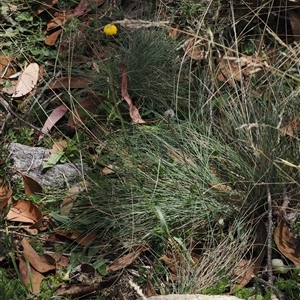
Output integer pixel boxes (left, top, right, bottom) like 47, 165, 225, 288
17, 254, 45, 294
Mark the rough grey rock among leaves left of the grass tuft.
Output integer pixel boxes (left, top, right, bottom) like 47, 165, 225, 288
8, 143, 89, 187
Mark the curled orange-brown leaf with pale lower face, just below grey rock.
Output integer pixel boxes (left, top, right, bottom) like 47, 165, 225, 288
6, 200, 43, 227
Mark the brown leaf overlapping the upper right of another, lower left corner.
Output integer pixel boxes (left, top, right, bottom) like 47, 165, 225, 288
21, 238, 55, 273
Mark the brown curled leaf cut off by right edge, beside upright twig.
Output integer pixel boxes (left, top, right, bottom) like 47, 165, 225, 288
274, 221, 300, 267
